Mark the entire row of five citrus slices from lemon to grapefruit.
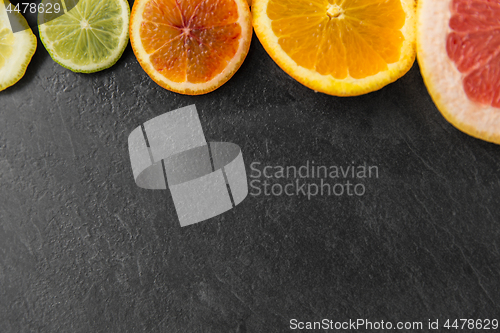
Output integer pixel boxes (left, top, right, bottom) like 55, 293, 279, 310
0, 0, 500, 144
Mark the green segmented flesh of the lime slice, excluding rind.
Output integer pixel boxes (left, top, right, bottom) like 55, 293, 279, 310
45, 0, 123, 66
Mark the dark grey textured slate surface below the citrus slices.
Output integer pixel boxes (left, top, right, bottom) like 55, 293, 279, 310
0, 1, 500, 333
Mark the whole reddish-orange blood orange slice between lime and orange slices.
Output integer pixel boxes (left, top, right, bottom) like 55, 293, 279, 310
130, 0, 252, 95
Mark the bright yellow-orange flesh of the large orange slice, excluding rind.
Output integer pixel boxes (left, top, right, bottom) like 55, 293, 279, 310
267, 0, 406, 79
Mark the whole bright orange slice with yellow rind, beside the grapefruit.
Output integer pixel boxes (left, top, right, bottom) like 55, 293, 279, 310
252, 0, 415, 96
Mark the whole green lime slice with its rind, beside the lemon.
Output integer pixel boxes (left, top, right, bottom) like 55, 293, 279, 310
38, 0, 130, 73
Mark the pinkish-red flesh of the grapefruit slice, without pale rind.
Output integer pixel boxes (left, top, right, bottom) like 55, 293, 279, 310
446, 0, 500, 108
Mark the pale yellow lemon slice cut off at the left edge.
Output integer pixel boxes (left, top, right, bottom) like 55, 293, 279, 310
0, 1, 36, 91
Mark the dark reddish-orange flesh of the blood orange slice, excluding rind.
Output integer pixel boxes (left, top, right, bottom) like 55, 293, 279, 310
140, 0, 241, 83
